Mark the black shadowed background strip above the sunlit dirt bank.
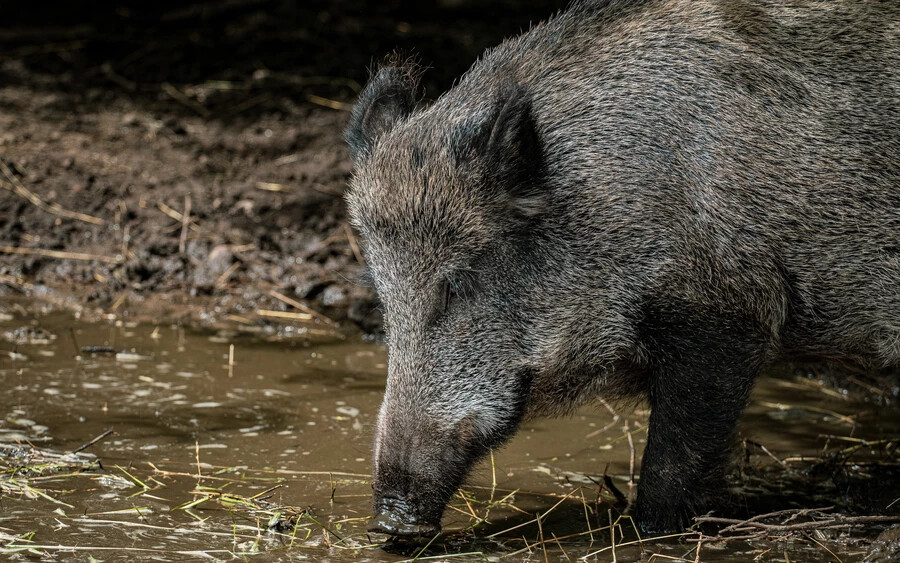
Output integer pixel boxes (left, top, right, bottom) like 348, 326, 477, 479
0, 0, 567, 109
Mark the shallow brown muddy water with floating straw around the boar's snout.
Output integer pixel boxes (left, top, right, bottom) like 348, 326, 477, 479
0, 305, 900, 561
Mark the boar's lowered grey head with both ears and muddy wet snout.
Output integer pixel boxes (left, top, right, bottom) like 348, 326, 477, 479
347, 64, 543, 536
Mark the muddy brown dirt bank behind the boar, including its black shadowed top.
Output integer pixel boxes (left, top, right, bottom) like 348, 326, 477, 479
0, 0, 564, 332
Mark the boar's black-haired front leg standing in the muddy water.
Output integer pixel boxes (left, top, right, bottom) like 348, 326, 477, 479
635, 305, 770, 534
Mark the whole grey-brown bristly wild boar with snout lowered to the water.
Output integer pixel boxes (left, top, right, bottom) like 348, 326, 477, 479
346, 0, 900, 536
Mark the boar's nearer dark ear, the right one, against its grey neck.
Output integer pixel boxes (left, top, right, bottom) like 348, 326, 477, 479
460, 84, 544, 216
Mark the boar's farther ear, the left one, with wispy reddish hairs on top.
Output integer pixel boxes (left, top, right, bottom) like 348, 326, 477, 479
344, 63, 420, 163
